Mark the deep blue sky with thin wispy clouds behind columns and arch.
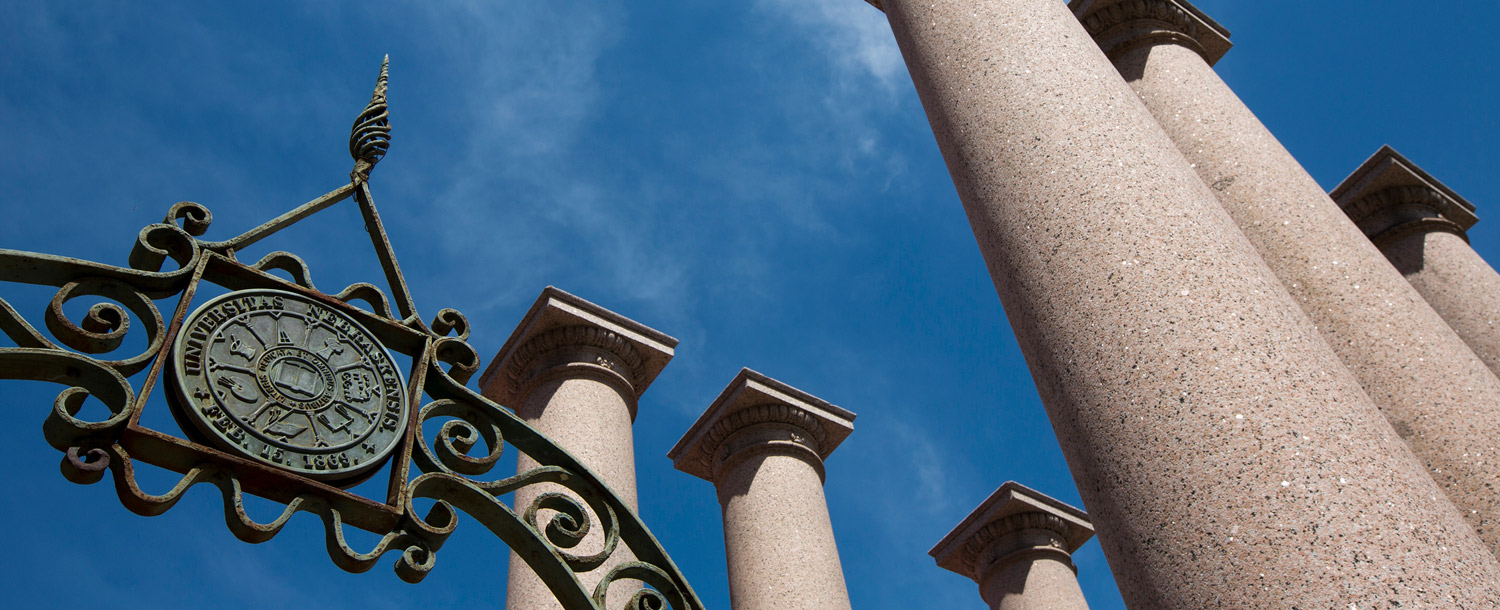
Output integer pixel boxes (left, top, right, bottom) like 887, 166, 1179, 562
0, 0, 1500, 609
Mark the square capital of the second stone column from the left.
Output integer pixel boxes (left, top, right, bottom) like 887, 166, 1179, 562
668, 369, 855, 483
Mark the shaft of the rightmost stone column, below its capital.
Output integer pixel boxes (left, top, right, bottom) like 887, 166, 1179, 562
1382, 231, 1500, 375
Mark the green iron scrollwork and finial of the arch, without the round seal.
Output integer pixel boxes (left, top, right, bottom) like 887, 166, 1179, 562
0, 57, 704, 610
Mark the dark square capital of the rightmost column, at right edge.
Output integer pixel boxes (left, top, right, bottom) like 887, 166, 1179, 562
1329, 145, 1479, 246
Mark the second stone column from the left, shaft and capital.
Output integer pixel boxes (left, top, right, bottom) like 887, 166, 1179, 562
668, 369, 855, 610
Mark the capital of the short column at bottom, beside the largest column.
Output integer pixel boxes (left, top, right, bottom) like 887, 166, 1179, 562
927, 481, 1094, 585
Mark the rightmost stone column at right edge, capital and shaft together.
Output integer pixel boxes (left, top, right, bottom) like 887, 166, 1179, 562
1331, 147, 1500, 375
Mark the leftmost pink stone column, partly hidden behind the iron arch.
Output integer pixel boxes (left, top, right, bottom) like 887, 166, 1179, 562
480, 286, 677, 610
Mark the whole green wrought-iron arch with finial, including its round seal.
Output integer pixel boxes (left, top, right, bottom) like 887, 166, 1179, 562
0, 57, 704, 610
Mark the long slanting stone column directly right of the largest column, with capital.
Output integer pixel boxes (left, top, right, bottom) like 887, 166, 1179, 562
1071, 0, 1500, 550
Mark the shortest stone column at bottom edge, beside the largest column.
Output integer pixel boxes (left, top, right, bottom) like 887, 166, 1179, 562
929, 481, 1094, 610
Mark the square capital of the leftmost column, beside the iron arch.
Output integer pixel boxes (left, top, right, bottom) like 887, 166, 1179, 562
479, 286, 677, 418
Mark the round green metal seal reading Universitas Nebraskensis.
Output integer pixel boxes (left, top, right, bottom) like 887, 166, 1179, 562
171, 289, 408, 483
